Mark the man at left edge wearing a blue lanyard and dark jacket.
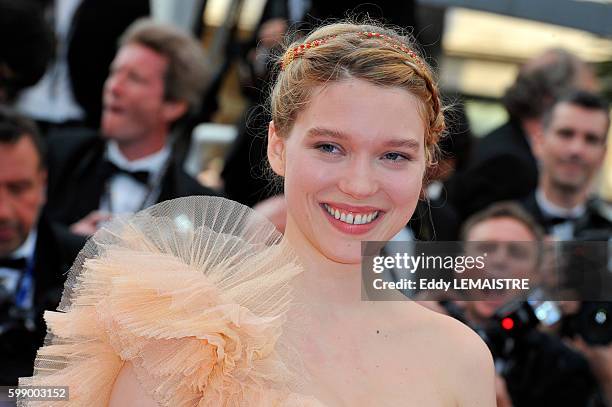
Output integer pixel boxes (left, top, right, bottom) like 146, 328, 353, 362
0, 108, 83, 385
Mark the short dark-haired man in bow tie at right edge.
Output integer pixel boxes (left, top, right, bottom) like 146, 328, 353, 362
522, 91, 612, 240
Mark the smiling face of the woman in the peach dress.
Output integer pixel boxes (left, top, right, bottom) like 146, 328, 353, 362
268, 79, 425, 264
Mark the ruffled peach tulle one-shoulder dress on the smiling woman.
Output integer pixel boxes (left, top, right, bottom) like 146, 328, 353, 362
19, 197, 321, 407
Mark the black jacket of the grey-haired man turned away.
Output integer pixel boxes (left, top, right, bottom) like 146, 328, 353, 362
446, 121, 538, 220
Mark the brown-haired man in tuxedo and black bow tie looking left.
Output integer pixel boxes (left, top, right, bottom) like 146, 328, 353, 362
48, 20, 214, 235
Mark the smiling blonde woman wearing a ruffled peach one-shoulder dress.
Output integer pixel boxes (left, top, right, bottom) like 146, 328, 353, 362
23, 19, 495, 407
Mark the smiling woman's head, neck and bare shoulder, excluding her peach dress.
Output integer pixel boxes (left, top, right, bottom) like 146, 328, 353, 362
268, 24, 495, 406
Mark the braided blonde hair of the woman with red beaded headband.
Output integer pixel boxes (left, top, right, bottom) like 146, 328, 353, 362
271, 23, 445, 166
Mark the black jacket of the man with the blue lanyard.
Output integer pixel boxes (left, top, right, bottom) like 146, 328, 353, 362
0, 213, 85, 385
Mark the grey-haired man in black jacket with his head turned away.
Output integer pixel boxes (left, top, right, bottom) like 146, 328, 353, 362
446, 49, 598, 220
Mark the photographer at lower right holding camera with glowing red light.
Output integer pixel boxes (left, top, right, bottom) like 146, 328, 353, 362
462, 203, 596, 407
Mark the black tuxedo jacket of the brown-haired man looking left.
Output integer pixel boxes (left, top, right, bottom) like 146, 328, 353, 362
47, 133, 217, 225
